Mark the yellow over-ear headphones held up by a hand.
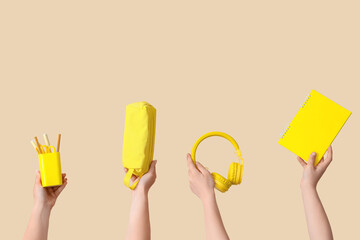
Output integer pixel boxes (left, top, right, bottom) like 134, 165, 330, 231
191, 132, 244, 192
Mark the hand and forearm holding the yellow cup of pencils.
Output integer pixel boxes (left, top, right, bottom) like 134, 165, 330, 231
23, 171, 67, 240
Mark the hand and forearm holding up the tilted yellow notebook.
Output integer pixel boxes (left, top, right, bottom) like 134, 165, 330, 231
297, 146, 334, 240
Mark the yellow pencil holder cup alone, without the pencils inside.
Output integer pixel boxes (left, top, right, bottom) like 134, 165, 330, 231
39, 152, 62, 187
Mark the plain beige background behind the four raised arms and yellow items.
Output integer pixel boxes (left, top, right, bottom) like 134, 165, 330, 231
0, 1, 360, 240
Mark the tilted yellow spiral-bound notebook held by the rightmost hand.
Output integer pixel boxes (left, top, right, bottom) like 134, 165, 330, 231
279, 90, 351, 165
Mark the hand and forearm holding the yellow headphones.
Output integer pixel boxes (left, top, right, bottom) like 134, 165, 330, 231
186, 153, 230, 240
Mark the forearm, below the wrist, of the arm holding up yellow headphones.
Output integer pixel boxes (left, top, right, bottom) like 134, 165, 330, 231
202, 193, 229, 240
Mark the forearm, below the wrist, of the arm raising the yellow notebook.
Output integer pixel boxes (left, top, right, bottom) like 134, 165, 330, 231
301, 186, 333, 240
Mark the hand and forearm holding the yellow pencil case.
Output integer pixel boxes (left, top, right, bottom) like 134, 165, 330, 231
125, 160, 157, 240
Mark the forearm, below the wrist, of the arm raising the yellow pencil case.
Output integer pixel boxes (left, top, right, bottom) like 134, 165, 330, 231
126, 189, 151, 240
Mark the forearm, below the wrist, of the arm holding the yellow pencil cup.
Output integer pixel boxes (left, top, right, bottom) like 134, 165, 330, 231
23, 204, 51, 240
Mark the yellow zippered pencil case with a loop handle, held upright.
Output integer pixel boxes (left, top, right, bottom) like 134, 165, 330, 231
123, 102, 156, 189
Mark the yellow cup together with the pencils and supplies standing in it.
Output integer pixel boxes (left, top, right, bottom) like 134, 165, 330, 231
31, 134, 62, 187
